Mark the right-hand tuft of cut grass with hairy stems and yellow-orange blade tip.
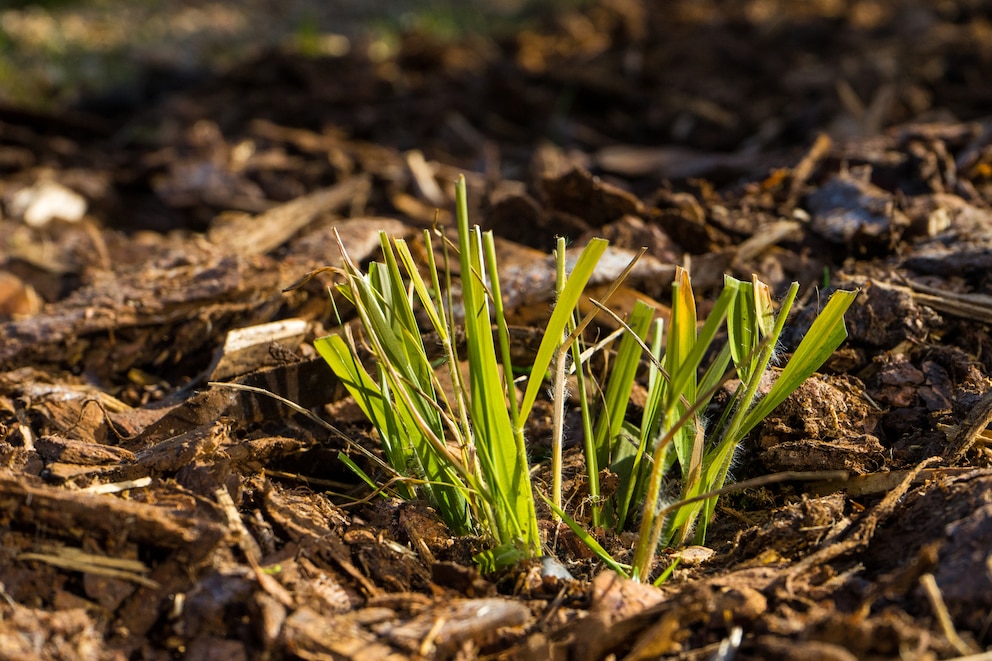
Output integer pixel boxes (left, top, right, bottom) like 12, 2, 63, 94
597, 268, 856, 580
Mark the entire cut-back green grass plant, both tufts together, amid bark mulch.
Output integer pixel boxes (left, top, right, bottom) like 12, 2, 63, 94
316, 178, 856, 580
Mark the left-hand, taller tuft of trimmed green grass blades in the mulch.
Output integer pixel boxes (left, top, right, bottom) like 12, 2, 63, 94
316, 174, 606, 567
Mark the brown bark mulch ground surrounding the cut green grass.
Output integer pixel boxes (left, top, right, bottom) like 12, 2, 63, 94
0, 0, 992, 660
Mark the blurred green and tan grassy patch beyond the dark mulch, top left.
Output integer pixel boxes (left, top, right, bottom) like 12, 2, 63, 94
0, 0, 582, 109
